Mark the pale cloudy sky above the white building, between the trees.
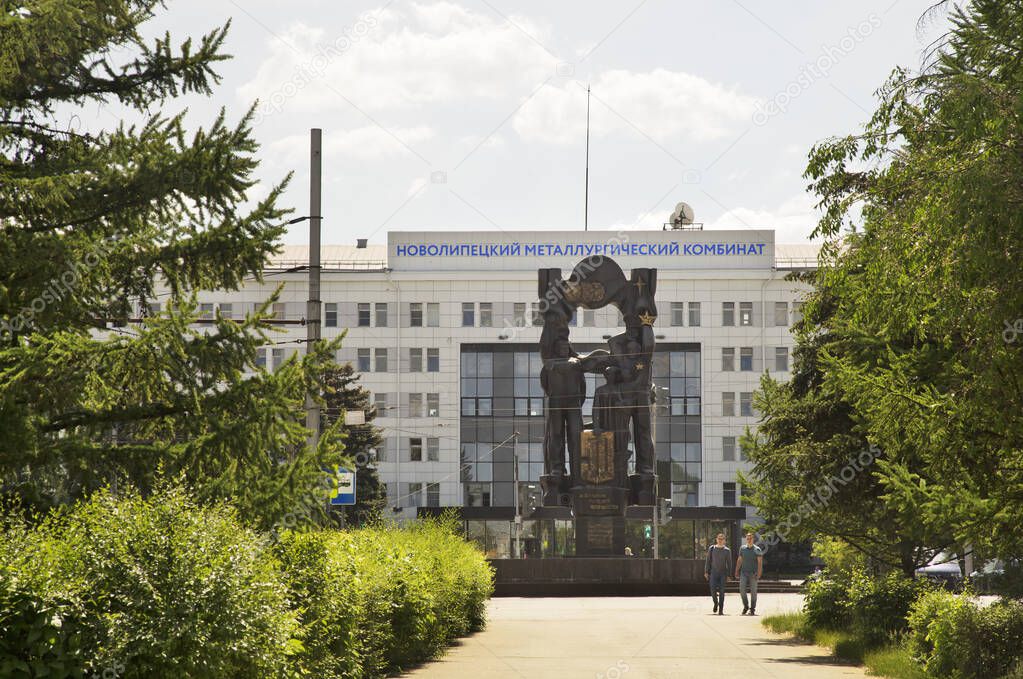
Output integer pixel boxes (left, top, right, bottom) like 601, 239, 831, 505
105, 0, 943, 243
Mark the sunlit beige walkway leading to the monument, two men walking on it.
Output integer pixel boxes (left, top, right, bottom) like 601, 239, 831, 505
403, 594, 866, 679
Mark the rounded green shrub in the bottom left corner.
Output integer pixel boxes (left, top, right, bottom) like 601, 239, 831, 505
2, 490, 297, 678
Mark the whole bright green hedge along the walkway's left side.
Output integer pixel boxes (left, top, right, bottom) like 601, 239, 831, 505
0, 489, 492, 679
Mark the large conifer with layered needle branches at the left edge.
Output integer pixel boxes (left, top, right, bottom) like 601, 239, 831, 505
0, 0, 341, 525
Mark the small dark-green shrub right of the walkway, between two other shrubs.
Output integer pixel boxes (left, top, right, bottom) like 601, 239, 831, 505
846, 572, 931, 646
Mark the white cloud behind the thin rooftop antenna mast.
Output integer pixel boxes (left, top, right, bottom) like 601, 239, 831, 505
514, 69, 756, 143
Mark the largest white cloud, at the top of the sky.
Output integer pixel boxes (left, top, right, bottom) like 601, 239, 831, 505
237, 2, 557, 112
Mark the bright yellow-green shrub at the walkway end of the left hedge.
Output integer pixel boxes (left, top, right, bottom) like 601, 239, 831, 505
276, 519, 493, 679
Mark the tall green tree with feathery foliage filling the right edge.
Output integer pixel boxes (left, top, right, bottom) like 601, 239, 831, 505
752, 0, 1023, 556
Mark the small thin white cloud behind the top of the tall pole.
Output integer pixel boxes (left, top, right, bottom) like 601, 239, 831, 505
270, 125, 434, 161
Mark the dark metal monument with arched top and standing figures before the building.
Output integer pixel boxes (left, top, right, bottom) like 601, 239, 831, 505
537, 257, 657, 556
